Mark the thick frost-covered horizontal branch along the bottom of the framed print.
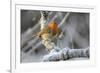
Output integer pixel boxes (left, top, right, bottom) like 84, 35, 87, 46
43, 48, 89, 61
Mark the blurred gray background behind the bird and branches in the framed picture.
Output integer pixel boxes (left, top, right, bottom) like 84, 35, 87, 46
20, 10, 90, 63
